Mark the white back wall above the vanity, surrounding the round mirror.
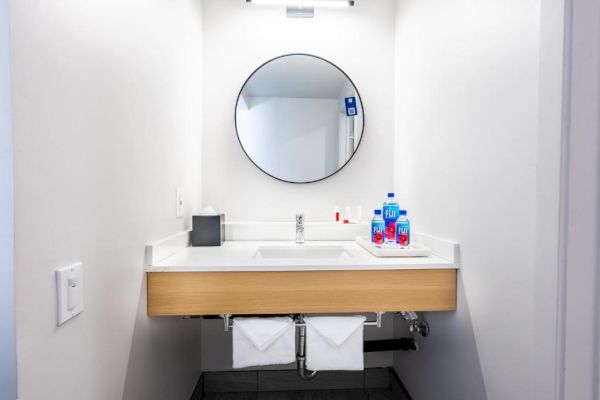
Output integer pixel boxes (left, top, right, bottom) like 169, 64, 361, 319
202, 0, 394, 221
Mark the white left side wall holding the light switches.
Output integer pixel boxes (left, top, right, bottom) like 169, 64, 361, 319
11, 0, 202, 400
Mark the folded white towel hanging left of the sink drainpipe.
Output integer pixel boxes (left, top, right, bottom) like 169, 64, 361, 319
233, 317, 296, 368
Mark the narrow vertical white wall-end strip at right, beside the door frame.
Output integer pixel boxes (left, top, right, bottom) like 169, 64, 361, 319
532, 0, 565, 399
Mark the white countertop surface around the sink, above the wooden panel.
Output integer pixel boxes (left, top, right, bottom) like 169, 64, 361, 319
145, 239, 458, 272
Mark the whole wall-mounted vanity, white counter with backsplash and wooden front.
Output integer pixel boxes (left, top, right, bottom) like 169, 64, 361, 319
146, 223, 458, 316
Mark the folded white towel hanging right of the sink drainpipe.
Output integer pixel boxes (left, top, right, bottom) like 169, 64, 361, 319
305, 315, 366, 371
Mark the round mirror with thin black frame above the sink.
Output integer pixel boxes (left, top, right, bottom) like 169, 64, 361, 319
235, 54, 364, 183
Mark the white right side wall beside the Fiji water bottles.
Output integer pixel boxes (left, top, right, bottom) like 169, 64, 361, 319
395, 0, 544, 400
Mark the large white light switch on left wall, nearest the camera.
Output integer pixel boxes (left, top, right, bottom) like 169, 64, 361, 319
56, 263, 83, 326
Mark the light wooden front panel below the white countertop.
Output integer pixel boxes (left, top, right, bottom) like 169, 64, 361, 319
148, 269, 456, 316
